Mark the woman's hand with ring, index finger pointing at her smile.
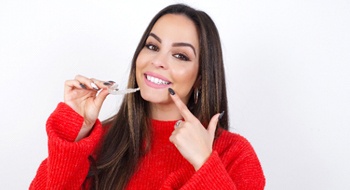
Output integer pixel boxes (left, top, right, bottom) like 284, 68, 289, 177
169, 88, 220, 171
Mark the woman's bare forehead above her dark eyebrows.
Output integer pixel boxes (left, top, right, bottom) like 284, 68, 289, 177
151, 14, 199, 48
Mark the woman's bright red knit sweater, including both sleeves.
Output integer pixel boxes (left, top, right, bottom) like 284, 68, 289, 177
30, 103, 265, 190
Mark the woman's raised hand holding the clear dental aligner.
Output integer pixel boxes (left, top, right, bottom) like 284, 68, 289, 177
64, 75, 113, 141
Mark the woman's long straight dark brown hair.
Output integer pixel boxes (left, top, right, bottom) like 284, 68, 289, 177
88, 4, 228, 189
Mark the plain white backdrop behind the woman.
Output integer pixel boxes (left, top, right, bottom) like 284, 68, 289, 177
0, 0, 350, 190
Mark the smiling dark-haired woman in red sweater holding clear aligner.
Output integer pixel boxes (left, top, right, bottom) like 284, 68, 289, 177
30, 4, 265, 190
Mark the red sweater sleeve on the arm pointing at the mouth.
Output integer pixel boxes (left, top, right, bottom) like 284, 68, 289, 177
181, 135, 265, 190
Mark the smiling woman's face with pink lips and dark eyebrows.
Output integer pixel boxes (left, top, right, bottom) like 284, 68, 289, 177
136, 14, 199, 104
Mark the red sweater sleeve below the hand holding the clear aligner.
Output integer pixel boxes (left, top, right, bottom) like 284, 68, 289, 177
29, 103, 103, 190
